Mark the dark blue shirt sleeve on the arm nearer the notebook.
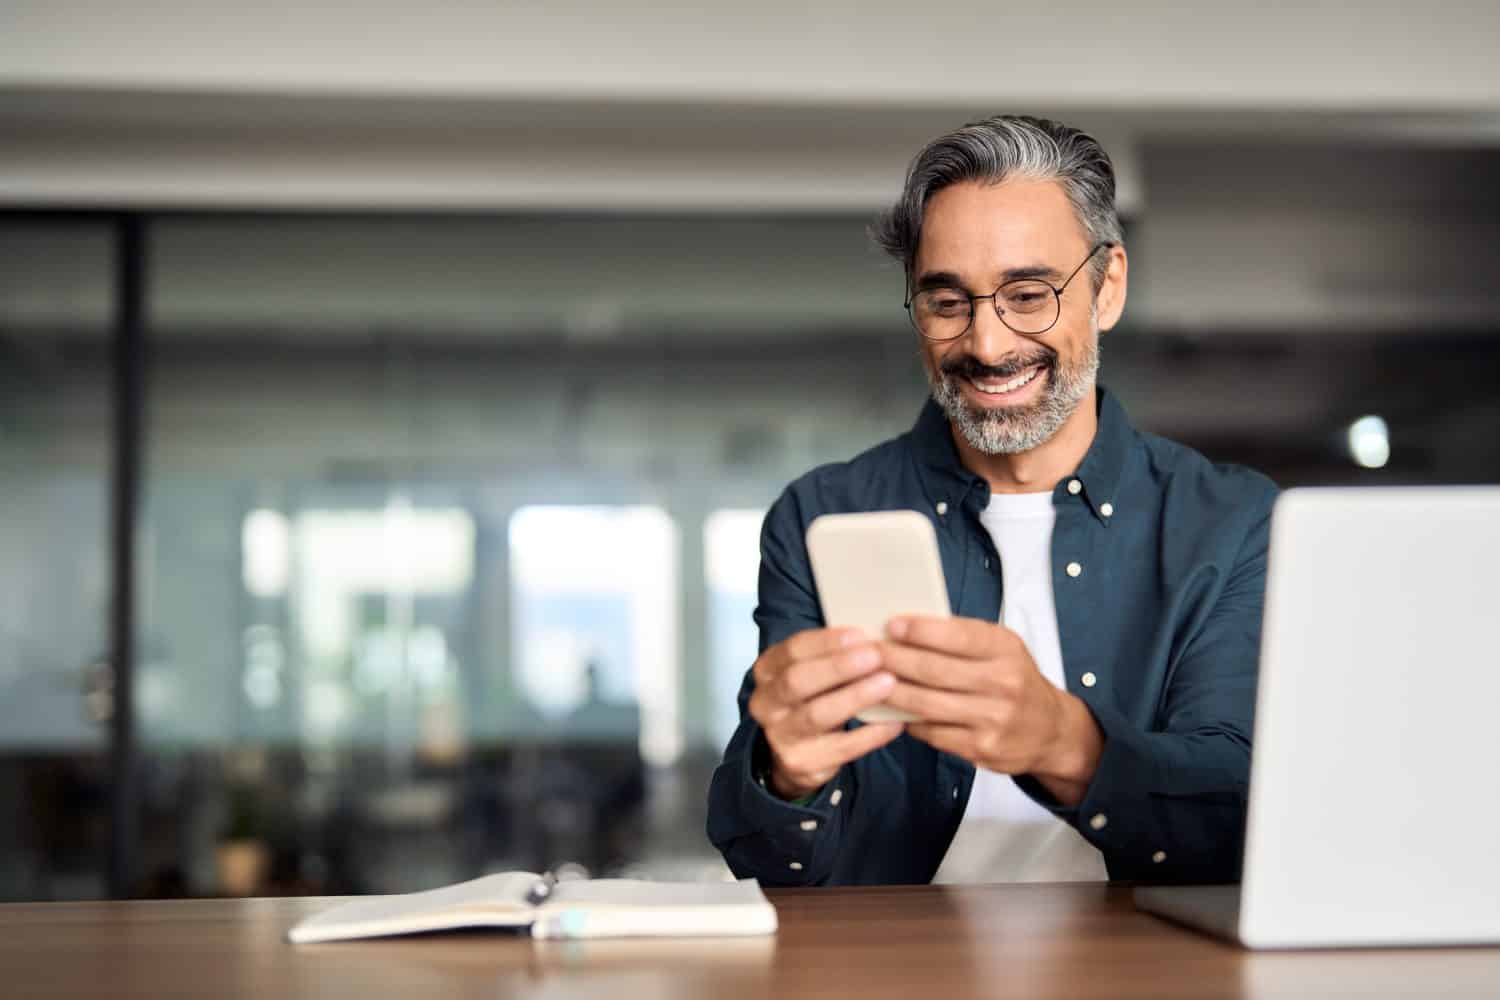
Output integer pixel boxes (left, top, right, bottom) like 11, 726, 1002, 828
708, 492, 857, 886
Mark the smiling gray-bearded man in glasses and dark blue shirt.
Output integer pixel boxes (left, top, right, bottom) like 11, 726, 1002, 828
708, 115, 1275, 885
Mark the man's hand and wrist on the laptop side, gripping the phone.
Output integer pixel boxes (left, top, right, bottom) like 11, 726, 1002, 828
881, 618, 1104, 805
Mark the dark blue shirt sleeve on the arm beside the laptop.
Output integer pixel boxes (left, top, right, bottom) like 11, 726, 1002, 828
1017, 489, 1275, 883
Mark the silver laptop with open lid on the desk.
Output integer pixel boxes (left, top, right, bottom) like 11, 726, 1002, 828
1136, 487, 1500, 948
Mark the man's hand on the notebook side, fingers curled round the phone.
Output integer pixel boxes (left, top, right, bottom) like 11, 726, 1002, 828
750, 628, 903, 799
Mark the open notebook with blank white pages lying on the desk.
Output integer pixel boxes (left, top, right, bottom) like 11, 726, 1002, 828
287, 871, 776, 945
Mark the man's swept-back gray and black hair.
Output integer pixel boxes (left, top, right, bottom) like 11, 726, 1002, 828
870, 114, 1125, 291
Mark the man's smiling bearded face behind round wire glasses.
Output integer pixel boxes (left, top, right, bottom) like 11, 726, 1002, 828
912, 180, 1124, 454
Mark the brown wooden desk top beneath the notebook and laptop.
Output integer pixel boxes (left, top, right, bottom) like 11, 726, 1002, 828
0, 886, 1500, 1000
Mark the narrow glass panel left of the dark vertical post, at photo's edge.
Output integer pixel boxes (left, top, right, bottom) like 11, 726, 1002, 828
0, 216, 114, 900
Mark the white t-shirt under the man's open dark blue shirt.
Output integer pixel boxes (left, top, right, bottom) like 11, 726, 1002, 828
933, 492, 1109, 883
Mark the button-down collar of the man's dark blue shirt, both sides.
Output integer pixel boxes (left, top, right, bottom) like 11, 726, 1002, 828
909, 385, 1137, 523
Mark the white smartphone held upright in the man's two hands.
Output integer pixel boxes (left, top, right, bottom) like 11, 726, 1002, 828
807, 510, 953, 723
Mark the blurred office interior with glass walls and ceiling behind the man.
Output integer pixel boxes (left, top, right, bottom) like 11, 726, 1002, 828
0, 0, 1500, 900
